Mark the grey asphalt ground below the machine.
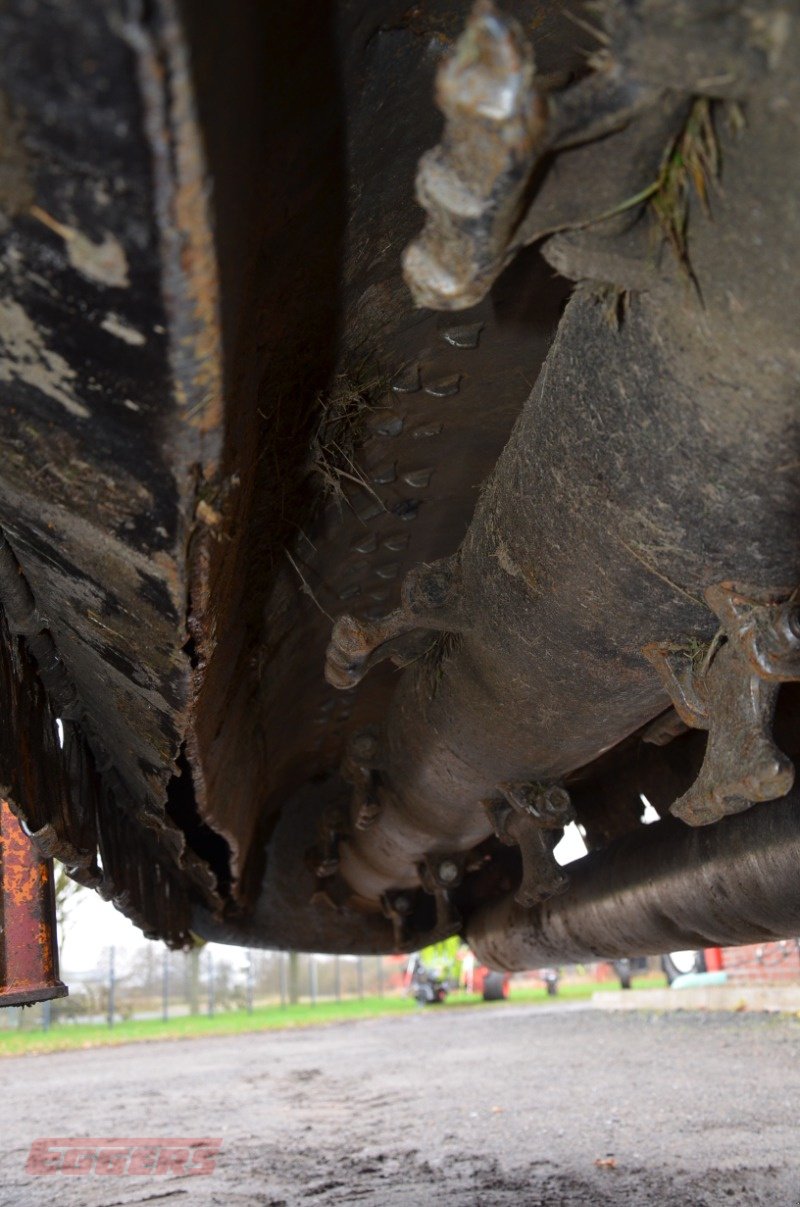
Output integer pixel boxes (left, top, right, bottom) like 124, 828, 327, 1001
0, 1004, 800, 1207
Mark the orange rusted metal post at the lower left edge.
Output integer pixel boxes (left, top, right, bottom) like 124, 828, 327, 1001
0, 799, 66, 1007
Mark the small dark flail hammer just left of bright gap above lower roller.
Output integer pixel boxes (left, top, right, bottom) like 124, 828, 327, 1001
484, 783, 576, 905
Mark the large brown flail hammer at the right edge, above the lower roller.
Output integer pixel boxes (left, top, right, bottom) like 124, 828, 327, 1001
642, 583, 800, 826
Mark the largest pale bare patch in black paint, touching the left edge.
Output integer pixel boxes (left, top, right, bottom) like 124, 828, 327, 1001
0, 299, 89, 419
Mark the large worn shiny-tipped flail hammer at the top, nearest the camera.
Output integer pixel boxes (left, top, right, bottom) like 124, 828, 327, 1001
403, 0, 660, 310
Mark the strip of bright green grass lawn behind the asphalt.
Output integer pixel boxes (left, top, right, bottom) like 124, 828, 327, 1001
0, 978, 661, 1056
